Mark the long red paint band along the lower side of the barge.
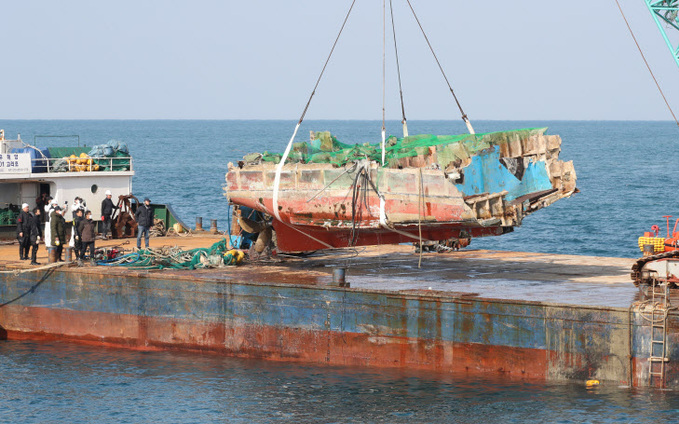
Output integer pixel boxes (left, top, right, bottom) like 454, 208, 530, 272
0, 307, 551, 380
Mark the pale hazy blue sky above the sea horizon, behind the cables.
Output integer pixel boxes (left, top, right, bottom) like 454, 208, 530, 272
0, 0, 679, 120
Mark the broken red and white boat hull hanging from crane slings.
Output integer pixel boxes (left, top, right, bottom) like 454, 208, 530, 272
226, 129, 577, 252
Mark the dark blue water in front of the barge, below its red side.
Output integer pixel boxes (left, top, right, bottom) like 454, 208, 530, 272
0, 342, 679, 424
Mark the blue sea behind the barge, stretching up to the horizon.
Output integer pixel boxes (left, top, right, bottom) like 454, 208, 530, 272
0, 120, 679, 257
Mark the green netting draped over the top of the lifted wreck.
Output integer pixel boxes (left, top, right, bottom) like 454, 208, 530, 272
250, 128, 546, 168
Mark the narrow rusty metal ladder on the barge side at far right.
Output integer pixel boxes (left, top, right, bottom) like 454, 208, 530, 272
648, 280, 670, 387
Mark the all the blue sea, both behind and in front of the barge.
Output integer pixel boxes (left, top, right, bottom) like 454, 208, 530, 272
0, 120, 679, 423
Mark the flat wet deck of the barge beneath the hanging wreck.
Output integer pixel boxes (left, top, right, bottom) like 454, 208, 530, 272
0, 235, 639, 308
